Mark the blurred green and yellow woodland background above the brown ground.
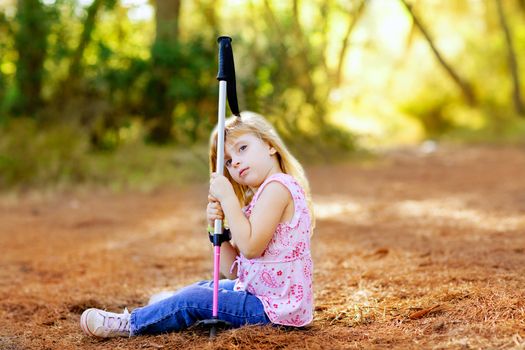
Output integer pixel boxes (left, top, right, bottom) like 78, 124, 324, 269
0, 0, 525, 190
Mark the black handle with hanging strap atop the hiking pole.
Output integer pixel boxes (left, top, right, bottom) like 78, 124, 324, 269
217, 36, 240, 116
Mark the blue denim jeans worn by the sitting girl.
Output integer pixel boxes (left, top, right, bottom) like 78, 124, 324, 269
130, 280, 271, 335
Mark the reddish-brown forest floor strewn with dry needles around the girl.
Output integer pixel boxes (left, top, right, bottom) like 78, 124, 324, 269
0, 146, 525, 350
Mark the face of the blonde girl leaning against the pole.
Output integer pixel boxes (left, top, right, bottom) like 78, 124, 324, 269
224, 133, 281, 188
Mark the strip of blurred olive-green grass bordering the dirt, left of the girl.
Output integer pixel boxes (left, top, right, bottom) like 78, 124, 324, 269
0, 118, 208, 190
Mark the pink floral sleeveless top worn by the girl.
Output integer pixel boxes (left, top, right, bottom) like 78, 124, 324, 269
232, 173, 313, 327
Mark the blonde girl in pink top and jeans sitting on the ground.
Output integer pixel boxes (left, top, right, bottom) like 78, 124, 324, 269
80, 112, 314, 337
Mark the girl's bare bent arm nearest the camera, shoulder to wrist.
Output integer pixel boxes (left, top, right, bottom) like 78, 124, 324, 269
221, 181, 292, 260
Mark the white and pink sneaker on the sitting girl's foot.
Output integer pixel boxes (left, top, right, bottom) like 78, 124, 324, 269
80, 308, 131, 338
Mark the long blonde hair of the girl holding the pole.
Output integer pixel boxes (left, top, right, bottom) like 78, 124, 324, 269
210, 112, 315, 234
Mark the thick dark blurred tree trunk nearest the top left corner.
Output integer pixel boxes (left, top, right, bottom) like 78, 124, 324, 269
10, 0, 48, 116
